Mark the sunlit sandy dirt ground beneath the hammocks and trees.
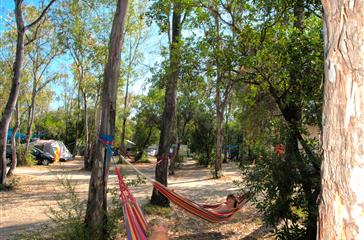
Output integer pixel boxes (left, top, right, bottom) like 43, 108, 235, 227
0, 158, 273, 240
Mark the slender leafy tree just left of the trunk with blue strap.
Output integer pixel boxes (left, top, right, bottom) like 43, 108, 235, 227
57, 0, 111, 170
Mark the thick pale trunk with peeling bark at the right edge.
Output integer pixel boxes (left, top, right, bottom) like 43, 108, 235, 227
318, 0, 364, 239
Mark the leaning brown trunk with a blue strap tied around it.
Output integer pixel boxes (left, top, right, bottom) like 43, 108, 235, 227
85, 0, 128, 239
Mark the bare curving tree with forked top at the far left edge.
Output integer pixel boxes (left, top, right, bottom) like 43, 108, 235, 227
0, 0, 56, 184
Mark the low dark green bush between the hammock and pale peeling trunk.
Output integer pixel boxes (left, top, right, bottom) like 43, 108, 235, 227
240, 141, 320, 239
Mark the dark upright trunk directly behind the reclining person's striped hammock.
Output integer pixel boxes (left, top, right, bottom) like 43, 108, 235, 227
151, 4, 181, 206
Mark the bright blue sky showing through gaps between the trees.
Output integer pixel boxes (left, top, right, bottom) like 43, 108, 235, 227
0, 0, 167, 109
